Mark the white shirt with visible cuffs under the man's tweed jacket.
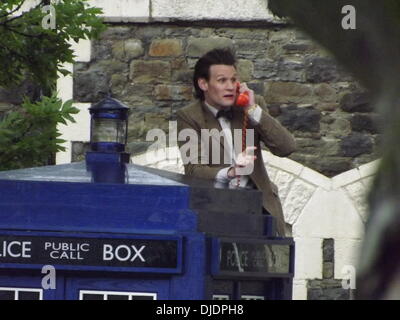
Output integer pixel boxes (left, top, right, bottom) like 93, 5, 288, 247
204, 102, 262, 188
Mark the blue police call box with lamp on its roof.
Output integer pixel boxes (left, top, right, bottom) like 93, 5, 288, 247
0, 98, 294, 300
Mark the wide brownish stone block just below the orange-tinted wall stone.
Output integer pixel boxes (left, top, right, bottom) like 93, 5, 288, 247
129, 60, 171, 84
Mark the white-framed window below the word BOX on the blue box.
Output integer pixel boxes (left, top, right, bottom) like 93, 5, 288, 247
79, 290, 157, 300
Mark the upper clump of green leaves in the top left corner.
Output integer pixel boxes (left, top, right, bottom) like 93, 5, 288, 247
0, 0, 105, 89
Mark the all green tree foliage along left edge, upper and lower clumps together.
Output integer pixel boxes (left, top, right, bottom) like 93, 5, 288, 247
0, 0, 105, 170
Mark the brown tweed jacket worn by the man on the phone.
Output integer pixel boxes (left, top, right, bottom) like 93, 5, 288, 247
177, 96, 296, 236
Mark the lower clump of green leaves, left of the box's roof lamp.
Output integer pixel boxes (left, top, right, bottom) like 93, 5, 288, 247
0, 95, 79, 170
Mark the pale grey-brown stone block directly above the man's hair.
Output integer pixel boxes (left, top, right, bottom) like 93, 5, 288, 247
187, 37, 233, 58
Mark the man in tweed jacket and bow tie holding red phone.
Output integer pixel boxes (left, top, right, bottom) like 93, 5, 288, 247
177, 49, 295, 236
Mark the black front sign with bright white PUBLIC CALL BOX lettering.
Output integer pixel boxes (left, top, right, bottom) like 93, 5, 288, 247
0, 233, 182, 273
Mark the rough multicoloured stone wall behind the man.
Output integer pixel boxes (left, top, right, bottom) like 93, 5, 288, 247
73, 23, 379, 177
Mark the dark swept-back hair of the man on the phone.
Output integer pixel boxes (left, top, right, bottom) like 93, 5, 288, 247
193, 48, 236, 101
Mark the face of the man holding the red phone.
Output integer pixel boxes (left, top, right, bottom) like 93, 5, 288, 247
198, 64, 237, 109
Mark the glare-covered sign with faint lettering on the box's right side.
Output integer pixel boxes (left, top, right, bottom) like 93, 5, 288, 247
211, 238, 294, 279
